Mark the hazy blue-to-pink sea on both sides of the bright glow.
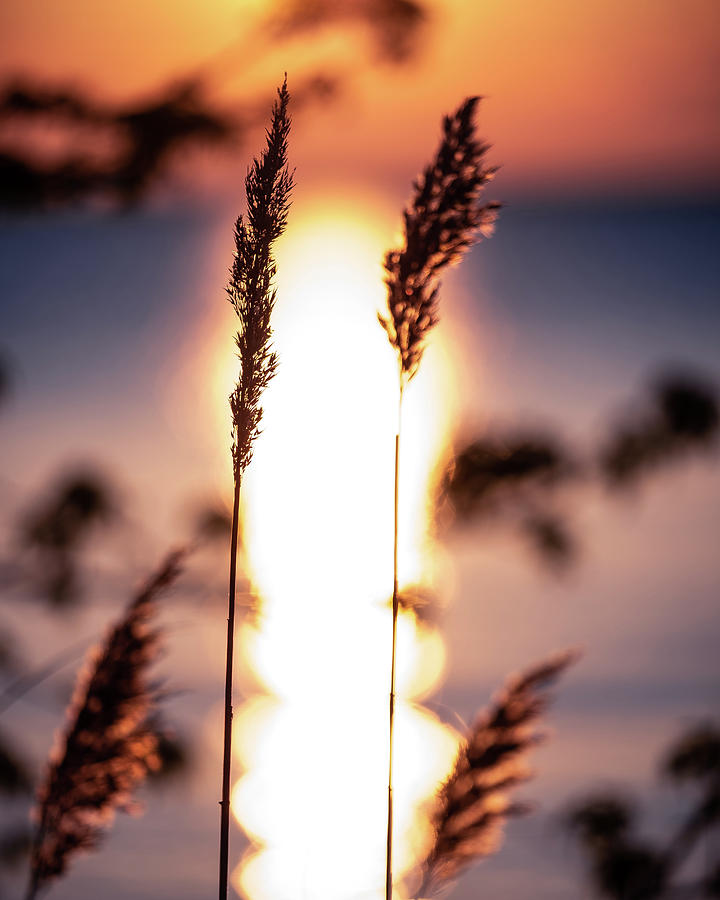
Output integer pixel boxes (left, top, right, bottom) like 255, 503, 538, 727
0, 202, 720, 900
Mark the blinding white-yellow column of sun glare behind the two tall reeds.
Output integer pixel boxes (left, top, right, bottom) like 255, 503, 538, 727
215, 204, 456, 900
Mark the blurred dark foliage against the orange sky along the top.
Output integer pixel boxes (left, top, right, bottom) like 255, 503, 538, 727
0, 0, 428, 213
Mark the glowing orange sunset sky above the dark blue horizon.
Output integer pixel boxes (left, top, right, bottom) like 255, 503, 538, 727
0, 0, 720, 196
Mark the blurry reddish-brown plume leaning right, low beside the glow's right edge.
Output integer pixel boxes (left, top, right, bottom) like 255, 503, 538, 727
418, 650, 578, 897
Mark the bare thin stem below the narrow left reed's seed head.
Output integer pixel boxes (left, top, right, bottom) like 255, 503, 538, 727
220, 466, 241, 900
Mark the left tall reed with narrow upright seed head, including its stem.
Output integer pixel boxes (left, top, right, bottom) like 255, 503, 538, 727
219, 78, 293, 900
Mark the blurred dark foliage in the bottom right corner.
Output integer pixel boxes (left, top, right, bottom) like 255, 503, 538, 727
566, 722, 720, 900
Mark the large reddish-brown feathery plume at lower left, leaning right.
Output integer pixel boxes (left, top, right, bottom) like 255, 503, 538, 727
27, 550, 185, 900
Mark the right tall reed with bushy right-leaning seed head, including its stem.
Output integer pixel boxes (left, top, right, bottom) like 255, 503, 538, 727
378, 97, 498, 900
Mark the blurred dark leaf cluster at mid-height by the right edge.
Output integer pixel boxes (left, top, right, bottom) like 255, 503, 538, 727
436, 371, 720, 568
